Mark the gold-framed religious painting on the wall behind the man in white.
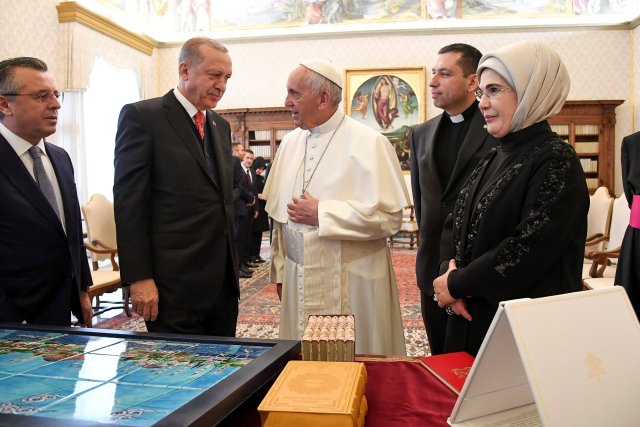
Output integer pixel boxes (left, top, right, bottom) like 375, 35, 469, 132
344, 67, 426, 170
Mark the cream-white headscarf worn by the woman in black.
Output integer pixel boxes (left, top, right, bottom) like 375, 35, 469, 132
477, 41, 571, 133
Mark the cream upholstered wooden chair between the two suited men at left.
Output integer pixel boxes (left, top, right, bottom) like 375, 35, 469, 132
82, 194, 131, 317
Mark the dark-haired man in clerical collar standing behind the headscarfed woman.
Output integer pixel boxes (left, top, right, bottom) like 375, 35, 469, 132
410, 43, 496, 354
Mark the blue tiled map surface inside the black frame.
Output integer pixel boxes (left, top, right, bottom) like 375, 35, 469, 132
0, 329, 268, 426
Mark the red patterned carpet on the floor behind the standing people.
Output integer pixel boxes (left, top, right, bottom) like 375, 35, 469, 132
95, 249, 429, 356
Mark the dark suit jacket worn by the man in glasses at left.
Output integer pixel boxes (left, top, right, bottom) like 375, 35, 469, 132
0, 135, 92, 326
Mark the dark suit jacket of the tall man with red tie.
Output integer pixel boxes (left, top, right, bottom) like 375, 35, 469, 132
113, 91, 240, 310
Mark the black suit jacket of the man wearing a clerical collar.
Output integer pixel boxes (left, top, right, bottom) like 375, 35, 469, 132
410, 110, 497, 295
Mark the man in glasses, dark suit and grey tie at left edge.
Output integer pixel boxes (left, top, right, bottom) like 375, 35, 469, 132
0, 57, 93, 326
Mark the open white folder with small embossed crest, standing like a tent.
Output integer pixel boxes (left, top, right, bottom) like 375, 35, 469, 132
448, 286, 640, 427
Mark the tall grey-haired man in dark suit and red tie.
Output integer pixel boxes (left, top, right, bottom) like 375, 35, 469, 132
113, 37, 240, 336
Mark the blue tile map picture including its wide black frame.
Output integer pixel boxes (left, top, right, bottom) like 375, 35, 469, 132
0, 324, 300, 427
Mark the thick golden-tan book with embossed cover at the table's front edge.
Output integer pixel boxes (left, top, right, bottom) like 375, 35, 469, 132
258, 360, 368, 427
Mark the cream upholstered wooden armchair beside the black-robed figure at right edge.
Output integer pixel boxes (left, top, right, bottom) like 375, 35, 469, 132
582, 194, 631, 289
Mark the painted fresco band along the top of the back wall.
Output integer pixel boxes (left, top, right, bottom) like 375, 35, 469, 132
65, 0, 640, 43
